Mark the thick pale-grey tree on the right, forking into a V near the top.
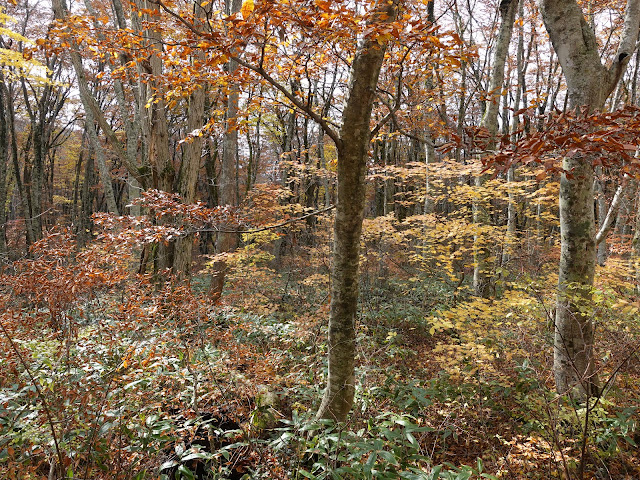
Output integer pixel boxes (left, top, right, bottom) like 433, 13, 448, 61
539, 0, 640, 396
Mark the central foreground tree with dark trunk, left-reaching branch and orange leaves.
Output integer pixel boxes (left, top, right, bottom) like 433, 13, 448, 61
151, 0, 448, 421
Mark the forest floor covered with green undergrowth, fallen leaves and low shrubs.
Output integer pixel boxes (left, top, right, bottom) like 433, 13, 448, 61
0, 232, 640, 480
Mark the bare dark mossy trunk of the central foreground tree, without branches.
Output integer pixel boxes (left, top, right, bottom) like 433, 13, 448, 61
317, 1, 397, 421
